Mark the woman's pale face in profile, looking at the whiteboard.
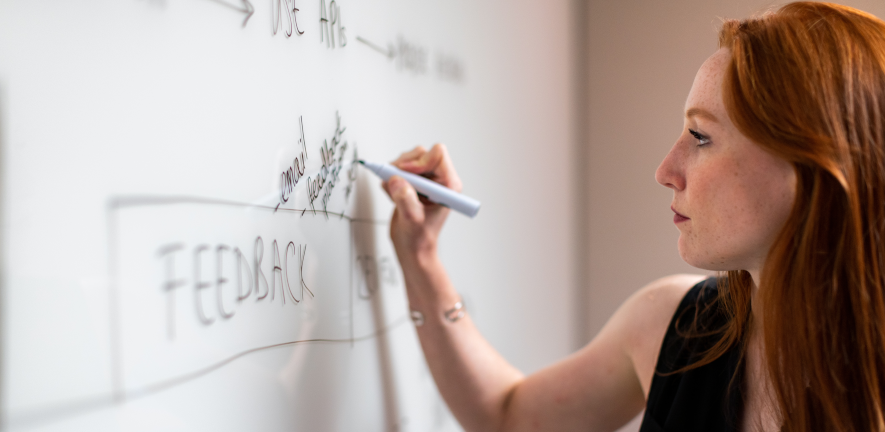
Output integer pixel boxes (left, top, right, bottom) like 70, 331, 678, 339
655, 48, 796, 273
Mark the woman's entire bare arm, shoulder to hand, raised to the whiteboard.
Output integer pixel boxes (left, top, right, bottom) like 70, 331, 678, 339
384, 144, 699, 431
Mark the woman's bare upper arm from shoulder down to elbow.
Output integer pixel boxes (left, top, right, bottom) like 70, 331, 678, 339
510, 275, 704, 430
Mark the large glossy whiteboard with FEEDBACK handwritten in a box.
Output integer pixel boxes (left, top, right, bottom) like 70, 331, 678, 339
0, 0, 576, 431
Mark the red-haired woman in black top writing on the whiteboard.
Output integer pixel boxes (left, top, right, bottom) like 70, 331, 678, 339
384, 2, 885, 431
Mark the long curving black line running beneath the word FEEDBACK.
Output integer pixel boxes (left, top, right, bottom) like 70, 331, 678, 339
7, 315, 409, 428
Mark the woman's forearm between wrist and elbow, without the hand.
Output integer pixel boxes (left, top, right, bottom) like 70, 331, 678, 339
400, 252, 523, 431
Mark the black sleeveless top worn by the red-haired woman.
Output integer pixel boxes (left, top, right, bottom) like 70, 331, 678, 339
639, 279, 743, 432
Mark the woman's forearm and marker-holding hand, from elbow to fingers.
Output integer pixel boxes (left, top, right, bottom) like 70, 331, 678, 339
383, 144, 523, 431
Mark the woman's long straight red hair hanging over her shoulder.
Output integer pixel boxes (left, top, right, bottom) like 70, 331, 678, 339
695, 2, 885, 431
